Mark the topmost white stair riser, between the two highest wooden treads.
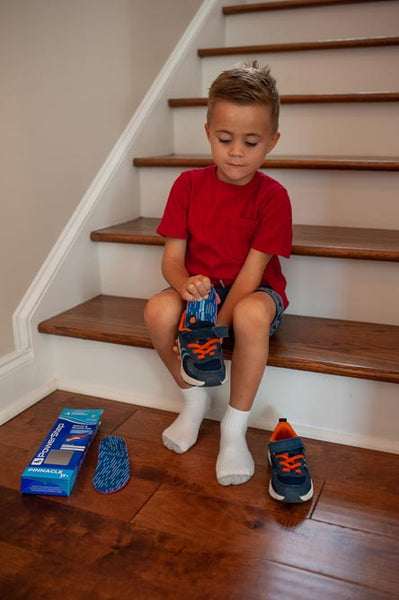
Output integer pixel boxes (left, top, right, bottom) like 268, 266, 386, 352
225, 2, 399, 46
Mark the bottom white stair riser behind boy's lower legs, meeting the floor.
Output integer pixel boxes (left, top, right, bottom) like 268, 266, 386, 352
54, 337, 399, 459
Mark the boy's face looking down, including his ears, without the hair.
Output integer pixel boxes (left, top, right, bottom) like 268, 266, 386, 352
205, 100, 280, 185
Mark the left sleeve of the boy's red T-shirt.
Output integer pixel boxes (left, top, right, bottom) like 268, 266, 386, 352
157, 172, 191, 240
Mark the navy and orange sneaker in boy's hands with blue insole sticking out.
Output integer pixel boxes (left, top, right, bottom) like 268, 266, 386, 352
177, 288, 229, 387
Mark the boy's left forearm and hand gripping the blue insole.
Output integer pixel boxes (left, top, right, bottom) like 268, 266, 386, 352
162, 238, 211, 302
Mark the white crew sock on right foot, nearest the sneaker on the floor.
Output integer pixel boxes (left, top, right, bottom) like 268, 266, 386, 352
216, 405, 255, 485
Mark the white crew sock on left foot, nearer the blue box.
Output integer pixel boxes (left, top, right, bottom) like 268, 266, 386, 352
162, 387, 210, 454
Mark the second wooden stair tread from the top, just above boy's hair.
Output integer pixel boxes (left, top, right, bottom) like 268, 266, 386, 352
197, 36, 399, 58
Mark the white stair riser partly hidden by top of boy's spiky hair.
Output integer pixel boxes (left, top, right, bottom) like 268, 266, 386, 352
202, 46, 399, 96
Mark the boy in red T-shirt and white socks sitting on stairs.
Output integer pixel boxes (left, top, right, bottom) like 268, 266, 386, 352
145, 62, 292, 485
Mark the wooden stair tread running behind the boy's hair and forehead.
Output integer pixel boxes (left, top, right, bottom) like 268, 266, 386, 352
168, 92, 399, 108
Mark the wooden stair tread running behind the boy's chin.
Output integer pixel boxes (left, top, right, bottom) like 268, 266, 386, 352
133, 154, 399, 171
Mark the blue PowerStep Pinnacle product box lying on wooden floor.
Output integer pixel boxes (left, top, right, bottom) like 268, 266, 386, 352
21, 408, 103, 496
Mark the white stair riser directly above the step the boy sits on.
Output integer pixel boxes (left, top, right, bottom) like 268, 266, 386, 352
99, 243, 399, 325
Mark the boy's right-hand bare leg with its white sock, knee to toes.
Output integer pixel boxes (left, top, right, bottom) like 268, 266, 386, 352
216, 292, 276, 485
